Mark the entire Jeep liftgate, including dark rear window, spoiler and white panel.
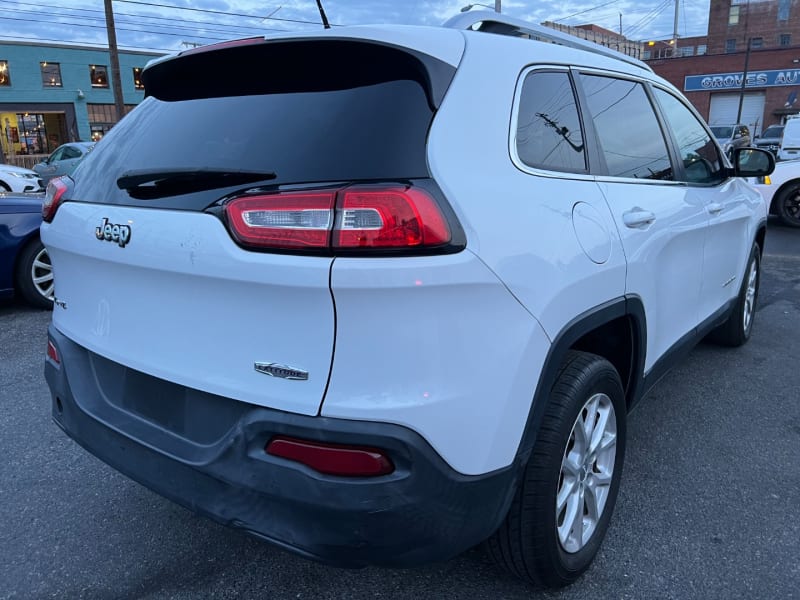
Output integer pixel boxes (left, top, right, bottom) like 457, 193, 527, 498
42, 29, 463, 415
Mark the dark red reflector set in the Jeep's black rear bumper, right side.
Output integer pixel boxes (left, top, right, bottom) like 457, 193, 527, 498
265, 436, 394, 477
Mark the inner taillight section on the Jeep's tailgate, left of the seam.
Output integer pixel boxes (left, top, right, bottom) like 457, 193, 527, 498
226, 191, 336, 249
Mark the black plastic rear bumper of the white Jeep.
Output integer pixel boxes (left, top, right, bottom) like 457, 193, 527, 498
45, 325, 519, 566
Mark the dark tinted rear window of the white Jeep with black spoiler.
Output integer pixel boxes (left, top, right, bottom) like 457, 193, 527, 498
73, 41, 454, 210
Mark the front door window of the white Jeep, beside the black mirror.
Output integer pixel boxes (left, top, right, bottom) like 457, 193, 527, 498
655, 89, 725, 183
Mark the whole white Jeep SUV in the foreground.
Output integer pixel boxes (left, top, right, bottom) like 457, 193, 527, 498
42, 11, 774, 586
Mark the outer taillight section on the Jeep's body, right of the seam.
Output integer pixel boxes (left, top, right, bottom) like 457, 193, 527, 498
333, 187, 450, 248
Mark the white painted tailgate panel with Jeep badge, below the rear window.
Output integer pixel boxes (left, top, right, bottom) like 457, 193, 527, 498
42, 202, 334, 414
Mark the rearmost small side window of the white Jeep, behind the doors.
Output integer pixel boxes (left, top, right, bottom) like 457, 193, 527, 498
516, 71, 586, 171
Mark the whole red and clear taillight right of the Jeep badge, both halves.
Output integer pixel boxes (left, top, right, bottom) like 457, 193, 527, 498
225, 185, 452, 251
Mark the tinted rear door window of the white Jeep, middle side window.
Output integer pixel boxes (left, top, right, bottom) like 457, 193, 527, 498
581, 75, 673, 180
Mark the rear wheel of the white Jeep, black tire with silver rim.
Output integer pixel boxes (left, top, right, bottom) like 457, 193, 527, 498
486, 351, 627, 588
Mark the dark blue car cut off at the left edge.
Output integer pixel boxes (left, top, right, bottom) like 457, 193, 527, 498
0, 193, 53, 308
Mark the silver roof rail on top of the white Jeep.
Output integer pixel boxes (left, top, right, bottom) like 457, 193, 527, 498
444, 10, 653, 72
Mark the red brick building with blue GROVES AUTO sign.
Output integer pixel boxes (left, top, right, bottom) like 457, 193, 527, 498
644, 0, 800, 134
